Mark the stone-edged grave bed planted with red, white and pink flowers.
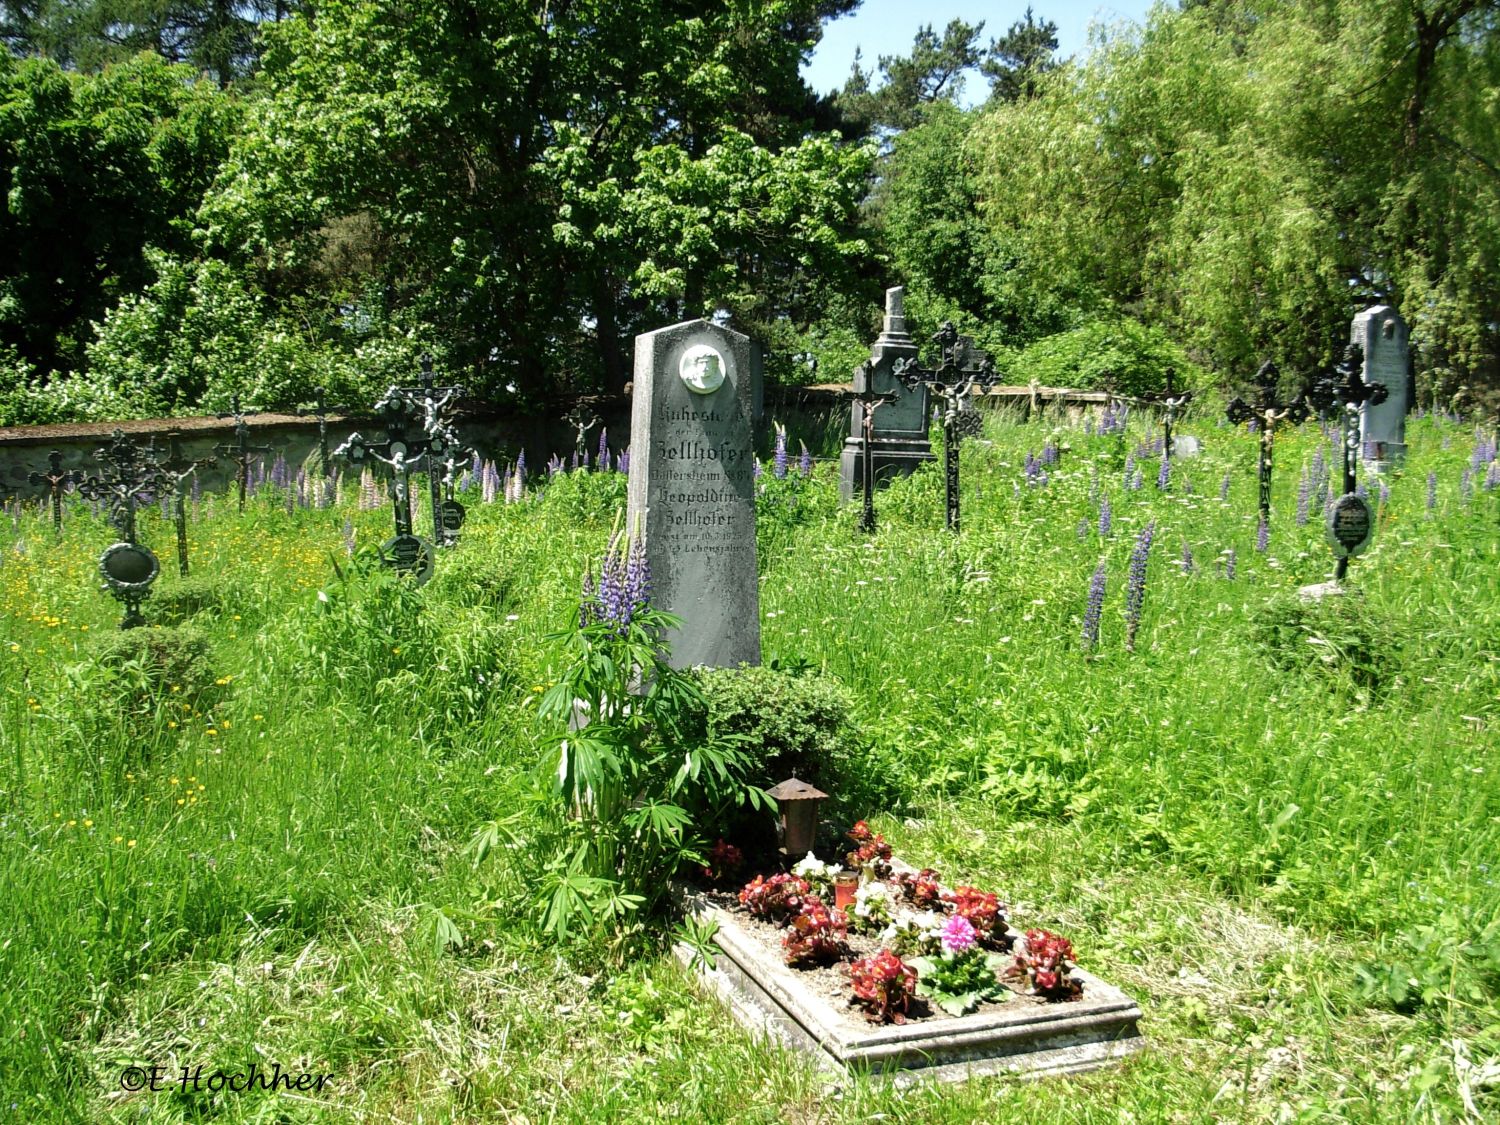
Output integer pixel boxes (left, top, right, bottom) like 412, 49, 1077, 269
690, 822, 1140, 1076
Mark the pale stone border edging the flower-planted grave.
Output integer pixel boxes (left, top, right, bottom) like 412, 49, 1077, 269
675, 893, 1145, 1085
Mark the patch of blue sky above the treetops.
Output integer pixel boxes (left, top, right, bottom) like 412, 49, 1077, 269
803, 0, 1151, 101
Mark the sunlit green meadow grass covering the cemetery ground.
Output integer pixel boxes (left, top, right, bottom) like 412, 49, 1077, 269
0, 413, 1500, 1122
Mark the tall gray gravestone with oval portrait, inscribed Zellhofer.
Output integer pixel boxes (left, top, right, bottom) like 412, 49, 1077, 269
629, 321, 761, 668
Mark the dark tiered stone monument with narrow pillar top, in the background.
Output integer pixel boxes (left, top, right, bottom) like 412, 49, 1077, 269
839, 287, 933, 500
